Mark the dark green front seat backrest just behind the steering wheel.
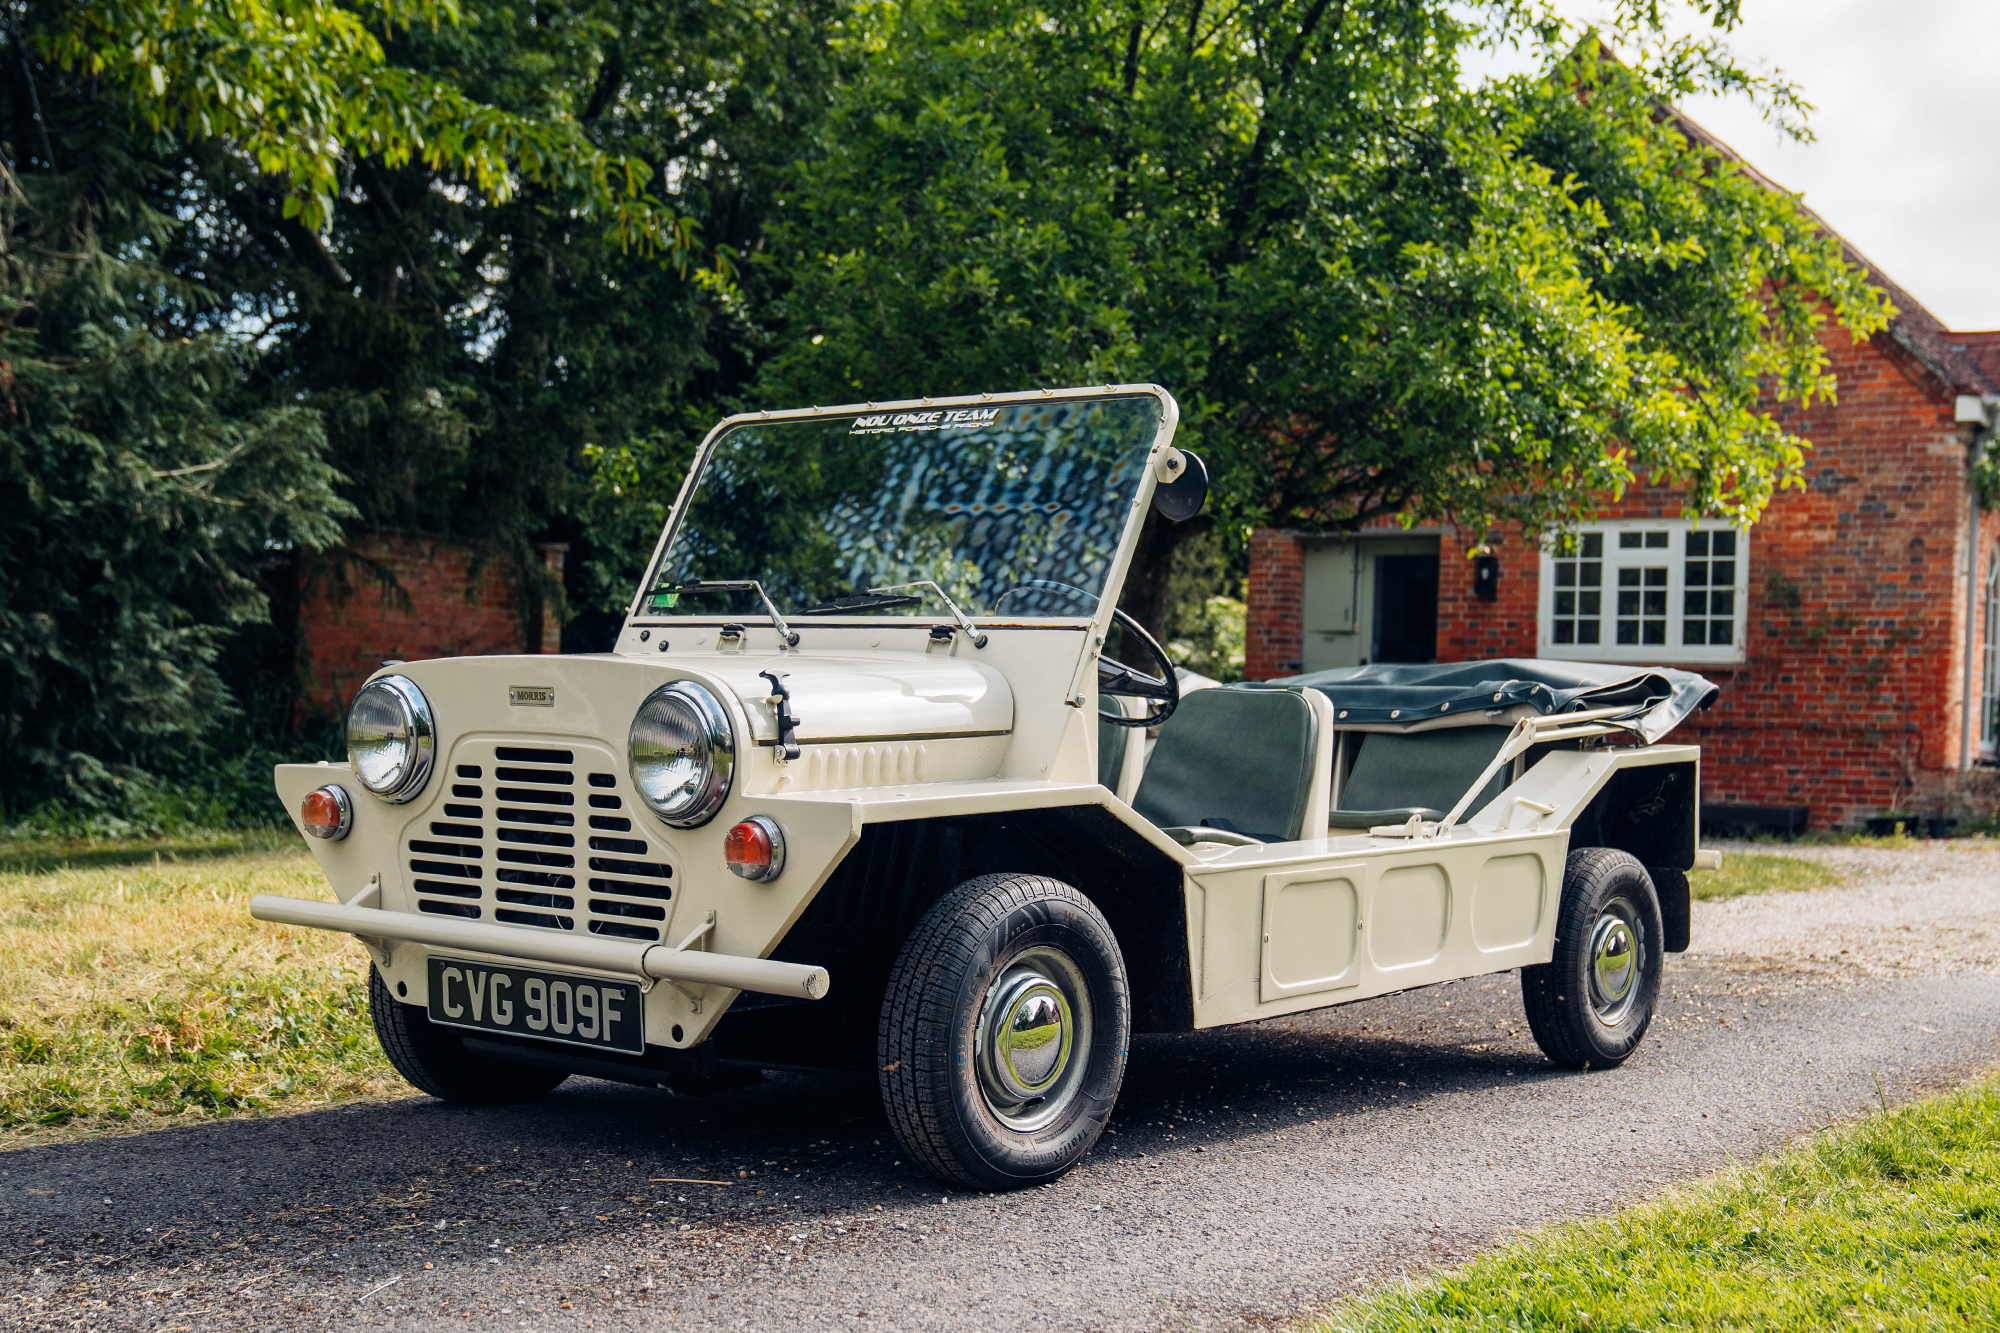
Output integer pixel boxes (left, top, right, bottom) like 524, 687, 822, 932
1132, 687, 1318, 843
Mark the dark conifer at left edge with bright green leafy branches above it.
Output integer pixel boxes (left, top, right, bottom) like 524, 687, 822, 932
0, 0, 690, 809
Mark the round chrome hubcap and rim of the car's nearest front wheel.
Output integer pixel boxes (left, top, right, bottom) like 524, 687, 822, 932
974, 949, 1090, 1131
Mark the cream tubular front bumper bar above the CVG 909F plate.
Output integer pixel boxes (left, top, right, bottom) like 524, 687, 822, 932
250, 893, 830, 999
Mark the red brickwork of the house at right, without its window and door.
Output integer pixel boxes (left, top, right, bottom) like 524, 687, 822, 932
1246, 324, 2000, 829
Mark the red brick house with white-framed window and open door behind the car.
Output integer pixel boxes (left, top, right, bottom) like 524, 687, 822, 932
1246, 122, 2000, 829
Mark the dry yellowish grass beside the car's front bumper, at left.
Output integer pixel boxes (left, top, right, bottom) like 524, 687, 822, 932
0, 833, 400, 1143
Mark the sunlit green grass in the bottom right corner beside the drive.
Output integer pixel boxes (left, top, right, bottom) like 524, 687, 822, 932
1308, 1077, 2000, 1333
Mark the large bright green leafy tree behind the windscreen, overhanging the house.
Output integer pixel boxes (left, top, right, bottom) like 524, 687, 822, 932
762, 0, 1886, 620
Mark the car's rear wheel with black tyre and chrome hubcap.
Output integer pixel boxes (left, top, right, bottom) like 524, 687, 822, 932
1520, 847, 1662, 1069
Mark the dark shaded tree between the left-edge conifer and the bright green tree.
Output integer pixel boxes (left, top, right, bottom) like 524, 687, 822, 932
186, 0, 836, 644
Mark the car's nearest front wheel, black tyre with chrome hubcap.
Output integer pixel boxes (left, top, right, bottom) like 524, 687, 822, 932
876, 875, 1132, 1189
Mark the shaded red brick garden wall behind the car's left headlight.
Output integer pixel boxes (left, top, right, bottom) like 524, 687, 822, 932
298, 532, 568, 717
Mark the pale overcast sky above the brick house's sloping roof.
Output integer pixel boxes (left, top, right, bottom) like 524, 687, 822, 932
1472, 0, 2000, 328
